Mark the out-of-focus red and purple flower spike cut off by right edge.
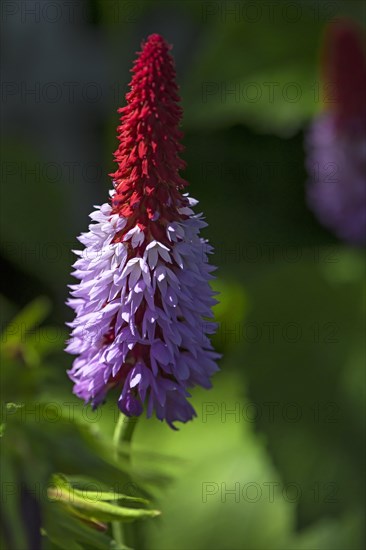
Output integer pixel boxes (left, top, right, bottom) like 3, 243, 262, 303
307, 20, 366, 244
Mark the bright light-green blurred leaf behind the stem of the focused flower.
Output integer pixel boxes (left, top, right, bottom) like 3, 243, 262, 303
136, 370, 295, 550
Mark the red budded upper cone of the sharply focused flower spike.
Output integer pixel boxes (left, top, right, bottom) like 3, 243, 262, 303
111, 34, 187, 222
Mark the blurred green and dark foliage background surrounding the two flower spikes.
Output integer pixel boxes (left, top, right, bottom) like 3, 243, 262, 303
1, 0, 365, 550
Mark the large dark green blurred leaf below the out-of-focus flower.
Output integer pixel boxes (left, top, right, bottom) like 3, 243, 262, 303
242, 258, 365, 523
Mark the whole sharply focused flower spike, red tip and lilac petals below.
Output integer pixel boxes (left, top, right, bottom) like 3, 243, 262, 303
67, 35, 219, 427
